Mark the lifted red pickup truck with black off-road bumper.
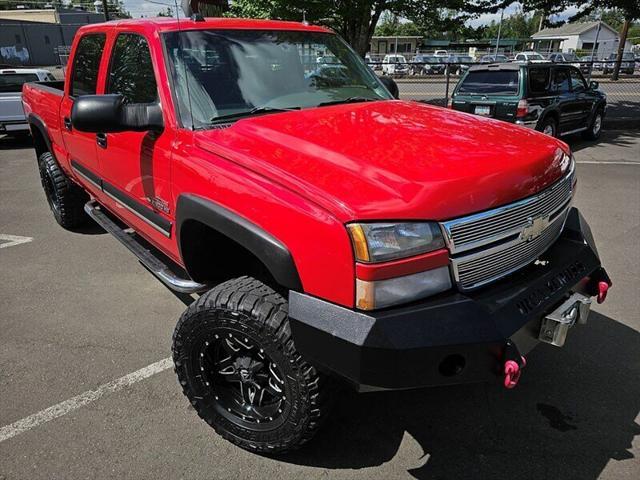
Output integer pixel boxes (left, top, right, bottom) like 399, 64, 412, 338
24, 18, 611, 452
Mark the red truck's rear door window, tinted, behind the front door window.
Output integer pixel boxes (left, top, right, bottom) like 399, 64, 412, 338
70, 33, 106, 95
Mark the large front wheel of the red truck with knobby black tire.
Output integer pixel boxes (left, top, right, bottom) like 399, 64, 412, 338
173, 277, 329, 453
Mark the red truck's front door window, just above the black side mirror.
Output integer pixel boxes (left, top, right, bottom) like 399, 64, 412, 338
107, 33, 158, 103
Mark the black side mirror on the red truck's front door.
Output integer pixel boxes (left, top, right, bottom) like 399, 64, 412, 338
71, 95, 164, 133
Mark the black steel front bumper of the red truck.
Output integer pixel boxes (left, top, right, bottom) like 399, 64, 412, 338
289, 208, 608, 391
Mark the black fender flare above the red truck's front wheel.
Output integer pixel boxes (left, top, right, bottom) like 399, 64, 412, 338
176, 194, 302, 291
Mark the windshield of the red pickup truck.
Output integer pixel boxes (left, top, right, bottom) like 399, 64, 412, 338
164, 30, 392, 128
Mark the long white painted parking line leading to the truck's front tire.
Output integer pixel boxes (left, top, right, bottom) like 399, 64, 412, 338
0, 358, 173, 443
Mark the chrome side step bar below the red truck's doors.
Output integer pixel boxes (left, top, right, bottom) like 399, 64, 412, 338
84, 200, 209, 293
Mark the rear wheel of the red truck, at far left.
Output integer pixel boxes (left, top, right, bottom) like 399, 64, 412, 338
38, 152, 89, 229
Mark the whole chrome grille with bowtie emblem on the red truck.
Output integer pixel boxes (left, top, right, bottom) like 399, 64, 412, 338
442, 163, 575, 291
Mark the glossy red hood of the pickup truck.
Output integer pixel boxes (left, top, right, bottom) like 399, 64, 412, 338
195, 101, 568, 221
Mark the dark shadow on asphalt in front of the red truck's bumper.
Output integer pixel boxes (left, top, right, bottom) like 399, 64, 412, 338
279, 312, 640, 480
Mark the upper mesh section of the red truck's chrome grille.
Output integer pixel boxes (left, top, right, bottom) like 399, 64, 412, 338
443, 169, 574, 254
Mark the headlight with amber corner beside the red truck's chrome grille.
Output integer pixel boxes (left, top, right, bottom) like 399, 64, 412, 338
347, 222, 444, 263
